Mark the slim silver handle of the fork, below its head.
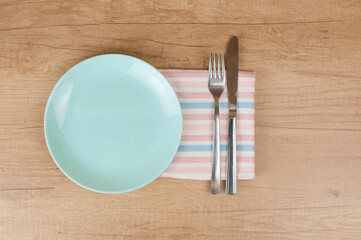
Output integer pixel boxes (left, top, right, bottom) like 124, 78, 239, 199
211, 98, 221, 194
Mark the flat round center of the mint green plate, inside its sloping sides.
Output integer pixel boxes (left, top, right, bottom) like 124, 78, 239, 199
64, 75, 164, 171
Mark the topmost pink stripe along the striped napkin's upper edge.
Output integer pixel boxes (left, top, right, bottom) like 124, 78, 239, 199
160, 69, 256, 79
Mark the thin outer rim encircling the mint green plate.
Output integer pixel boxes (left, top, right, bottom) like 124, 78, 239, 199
43, 53, 183, 194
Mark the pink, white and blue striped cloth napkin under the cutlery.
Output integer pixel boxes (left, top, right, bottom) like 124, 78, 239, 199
160, 70, 255, 180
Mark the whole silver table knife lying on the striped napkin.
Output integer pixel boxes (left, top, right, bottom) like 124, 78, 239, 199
226, 36, 238, 194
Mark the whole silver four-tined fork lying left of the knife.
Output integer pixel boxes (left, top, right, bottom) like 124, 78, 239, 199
208, 53, 225, 194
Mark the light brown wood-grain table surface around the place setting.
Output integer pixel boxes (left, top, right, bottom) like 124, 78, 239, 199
0, 0, 361, 240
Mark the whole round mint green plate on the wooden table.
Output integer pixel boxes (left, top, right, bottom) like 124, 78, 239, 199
44, 54, 182, 193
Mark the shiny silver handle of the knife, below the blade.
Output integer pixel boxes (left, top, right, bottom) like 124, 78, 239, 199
226, 117, 237, 194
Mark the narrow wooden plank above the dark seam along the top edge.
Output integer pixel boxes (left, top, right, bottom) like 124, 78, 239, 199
0, 0, 361, 29
